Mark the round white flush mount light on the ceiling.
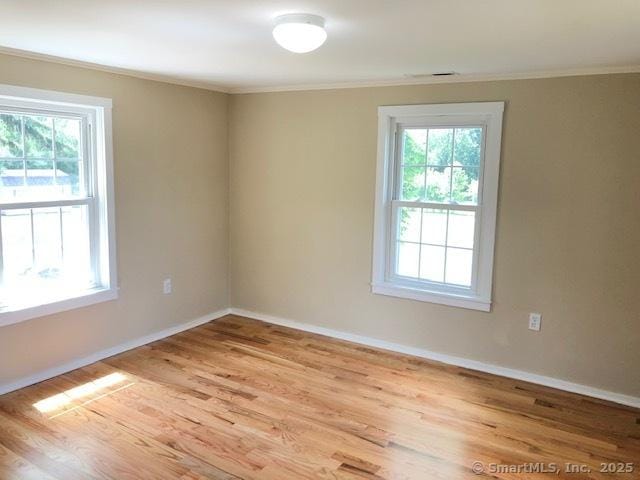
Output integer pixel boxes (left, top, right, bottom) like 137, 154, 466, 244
273, 13, 327, 53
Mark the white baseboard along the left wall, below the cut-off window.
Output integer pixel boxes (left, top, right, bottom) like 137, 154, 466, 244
0, 308, 231, 395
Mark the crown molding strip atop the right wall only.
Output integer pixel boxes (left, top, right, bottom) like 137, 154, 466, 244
228, 65, 640, 94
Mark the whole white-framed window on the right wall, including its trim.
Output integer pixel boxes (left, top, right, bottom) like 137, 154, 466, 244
372, 102, 504, 311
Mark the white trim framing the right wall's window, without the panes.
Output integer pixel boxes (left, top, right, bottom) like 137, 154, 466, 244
371, 102, 504, 312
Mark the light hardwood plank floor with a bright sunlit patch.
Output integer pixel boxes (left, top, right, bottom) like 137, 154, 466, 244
0, 316, 640, 480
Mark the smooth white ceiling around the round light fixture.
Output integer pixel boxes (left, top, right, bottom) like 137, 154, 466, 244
0, 0, 640, 91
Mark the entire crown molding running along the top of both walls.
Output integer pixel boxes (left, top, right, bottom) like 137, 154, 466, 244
0, 46, 640, 94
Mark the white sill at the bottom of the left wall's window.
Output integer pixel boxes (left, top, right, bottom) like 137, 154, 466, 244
0, 288, 118, 327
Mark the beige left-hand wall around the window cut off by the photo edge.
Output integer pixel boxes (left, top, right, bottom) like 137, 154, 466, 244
0, 55, 228, 385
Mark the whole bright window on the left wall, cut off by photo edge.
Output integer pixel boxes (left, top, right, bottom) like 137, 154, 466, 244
0, 85, 117, 325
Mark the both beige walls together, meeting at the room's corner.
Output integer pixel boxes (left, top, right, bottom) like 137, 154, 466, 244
0, 55, 640, 396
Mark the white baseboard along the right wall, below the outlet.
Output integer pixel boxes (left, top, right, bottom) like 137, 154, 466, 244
230, 308, 640, 408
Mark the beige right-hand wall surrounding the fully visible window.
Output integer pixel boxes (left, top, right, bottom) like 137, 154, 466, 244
229, 74, 640, 396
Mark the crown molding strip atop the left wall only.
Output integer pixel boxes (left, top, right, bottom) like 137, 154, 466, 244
0, 47, 230, 93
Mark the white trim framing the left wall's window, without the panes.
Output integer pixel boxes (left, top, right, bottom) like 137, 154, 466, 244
0, 85, 118, 327
